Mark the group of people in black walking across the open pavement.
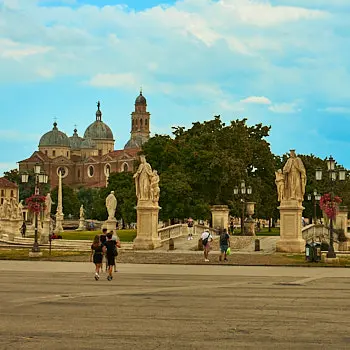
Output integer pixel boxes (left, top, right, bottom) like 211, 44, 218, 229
90, 228, 120, 281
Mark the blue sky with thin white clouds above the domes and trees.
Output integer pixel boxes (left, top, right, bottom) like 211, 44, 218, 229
0, 0, 350, 175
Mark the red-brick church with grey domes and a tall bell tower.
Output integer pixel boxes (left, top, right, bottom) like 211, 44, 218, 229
18, 91, 150, 188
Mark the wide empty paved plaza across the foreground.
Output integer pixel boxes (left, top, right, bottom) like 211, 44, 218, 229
0, 261, 350, 350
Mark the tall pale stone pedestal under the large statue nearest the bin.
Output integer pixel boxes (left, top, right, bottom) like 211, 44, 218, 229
276, 200, 305, 253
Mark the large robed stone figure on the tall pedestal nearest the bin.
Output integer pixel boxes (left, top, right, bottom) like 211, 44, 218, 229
283, 150, 306, 202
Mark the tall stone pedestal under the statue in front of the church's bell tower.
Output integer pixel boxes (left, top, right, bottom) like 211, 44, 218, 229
133, 200, 162, 250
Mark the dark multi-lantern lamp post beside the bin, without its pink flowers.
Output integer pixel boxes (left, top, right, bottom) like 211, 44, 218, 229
316, 156, 346, 258
